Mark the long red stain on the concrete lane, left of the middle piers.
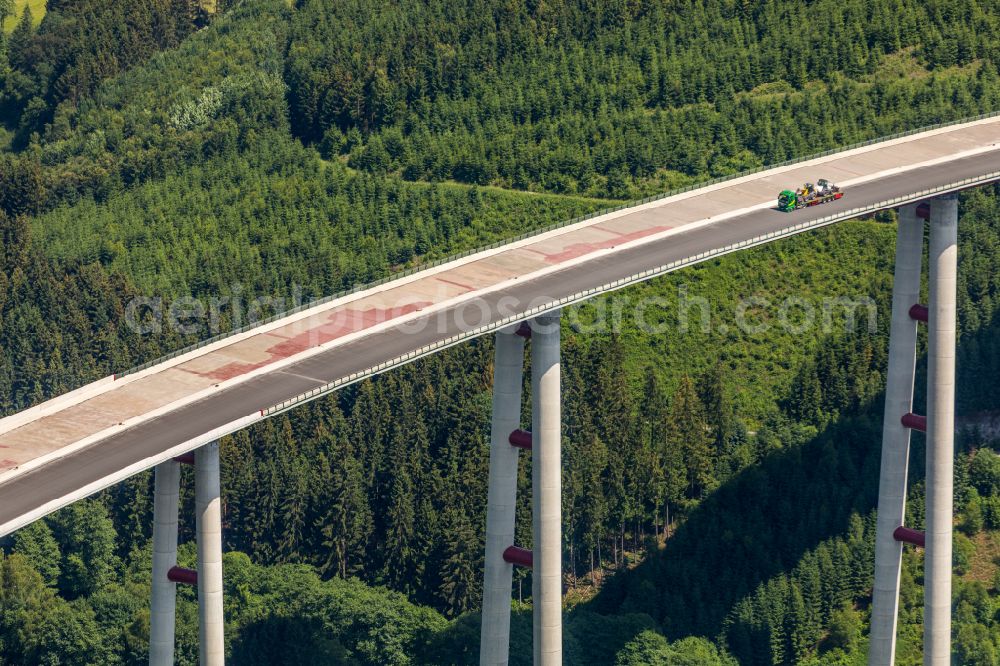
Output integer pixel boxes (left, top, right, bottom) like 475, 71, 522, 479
194, 301, 431, 381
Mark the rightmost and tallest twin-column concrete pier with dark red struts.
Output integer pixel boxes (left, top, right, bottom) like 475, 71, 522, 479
868, 194, 958, 666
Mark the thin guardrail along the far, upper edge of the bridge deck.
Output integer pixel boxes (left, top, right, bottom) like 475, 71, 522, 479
115, 111, 1000, 379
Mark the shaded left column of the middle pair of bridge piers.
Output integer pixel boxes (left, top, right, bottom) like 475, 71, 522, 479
479, 329, 524, 666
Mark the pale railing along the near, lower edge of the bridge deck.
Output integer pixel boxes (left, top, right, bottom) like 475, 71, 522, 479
260, 171, 1000, 418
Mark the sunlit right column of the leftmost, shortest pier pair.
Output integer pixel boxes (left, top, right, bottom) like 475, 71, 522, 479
194, 442, 226, 666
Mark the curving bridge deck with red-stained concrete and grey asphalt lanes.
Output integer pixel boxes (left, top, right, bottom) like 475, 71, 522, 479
0, 113, 1000, 533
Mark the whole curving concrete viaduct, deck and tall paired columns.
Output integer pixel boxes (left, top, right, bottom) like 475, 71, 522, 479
0, 115, 1000, 666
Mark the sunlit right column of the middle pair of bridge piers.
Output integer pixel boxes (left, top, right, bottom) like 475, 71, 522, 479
531, 312, 562, 666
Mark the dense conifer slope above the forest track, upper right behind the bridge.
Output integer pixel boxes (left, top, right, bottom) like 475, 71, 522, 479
286, 0, 1000, 198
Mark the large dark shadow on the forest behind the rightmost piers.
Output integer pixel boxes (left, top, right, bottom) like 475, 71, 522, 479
576, 304, 1000, 640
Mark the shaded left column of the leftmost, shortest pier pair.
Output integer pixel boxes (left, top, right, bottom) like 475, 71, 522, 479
149, 460, 181, 666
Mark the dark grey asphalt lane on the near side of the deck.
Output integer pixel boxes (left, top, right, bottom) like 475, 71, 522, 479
0, 151, 1000, 524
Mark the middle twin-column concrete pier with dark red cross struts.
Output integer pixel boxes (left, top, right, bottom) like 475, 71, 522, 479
479, 311, 562, 666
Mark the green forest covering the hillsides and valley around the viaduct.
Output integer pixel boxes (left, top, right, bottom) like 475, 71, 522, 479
0, 0, 1000, 666
